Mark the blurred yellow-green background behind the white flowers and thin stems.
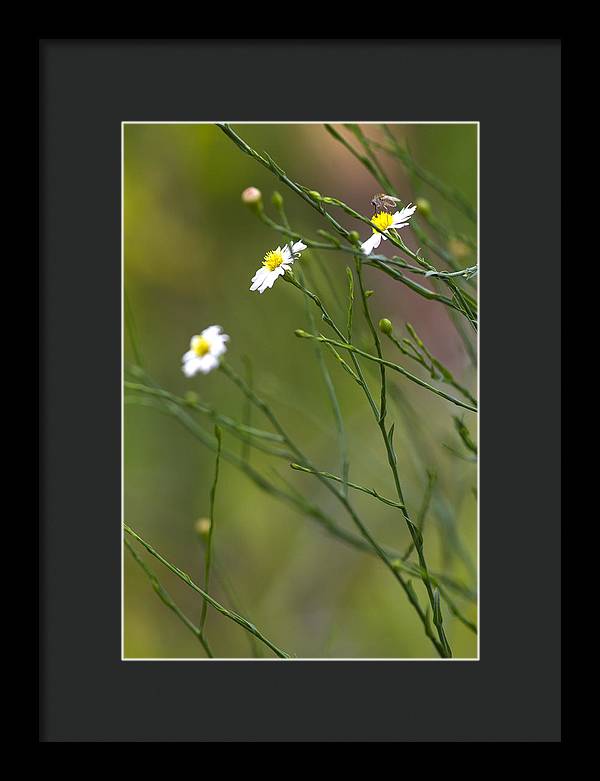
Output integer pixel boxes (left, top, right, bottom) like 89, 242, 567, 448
124, 124, 477, 659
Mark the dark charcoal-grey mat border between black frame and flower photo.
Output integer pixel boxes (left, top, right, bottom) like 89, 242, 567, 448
39, 39, 561, 742
